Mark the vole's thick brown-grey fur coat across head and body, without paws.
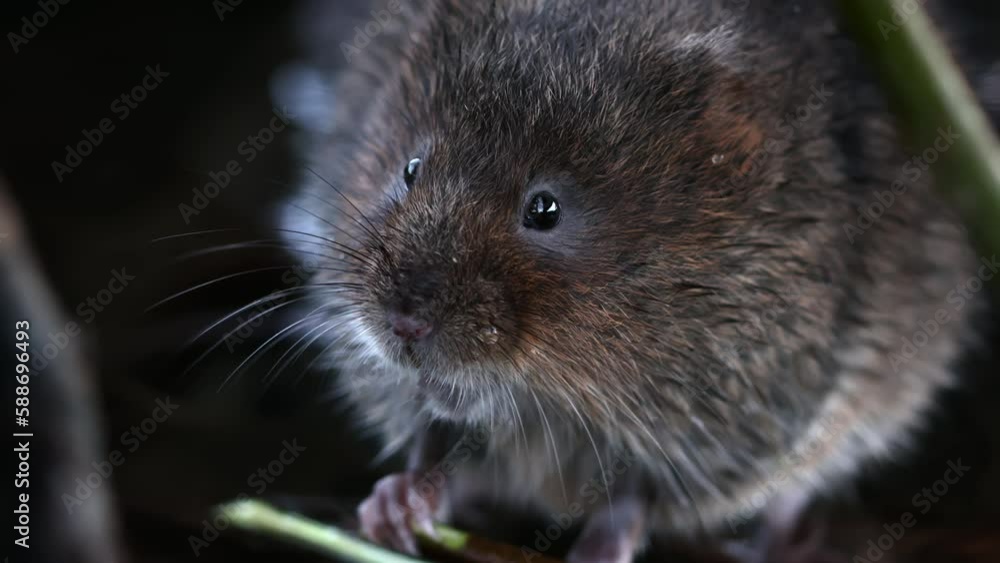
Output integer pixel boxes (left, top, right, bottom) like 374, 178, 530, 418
286, 0, 979, 527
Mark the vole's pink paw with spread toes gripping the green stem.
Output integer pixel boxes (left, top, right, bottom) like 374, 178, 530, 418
358, 473, 445, 555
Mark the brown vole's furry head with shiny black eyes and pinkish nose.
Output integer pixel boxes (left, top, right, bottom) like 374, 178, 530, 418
296, 2, 852, 472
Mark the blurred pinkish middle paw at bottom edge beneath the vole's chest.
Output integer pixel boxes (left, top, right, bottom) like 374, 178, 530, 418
566, 499, 645, 563
